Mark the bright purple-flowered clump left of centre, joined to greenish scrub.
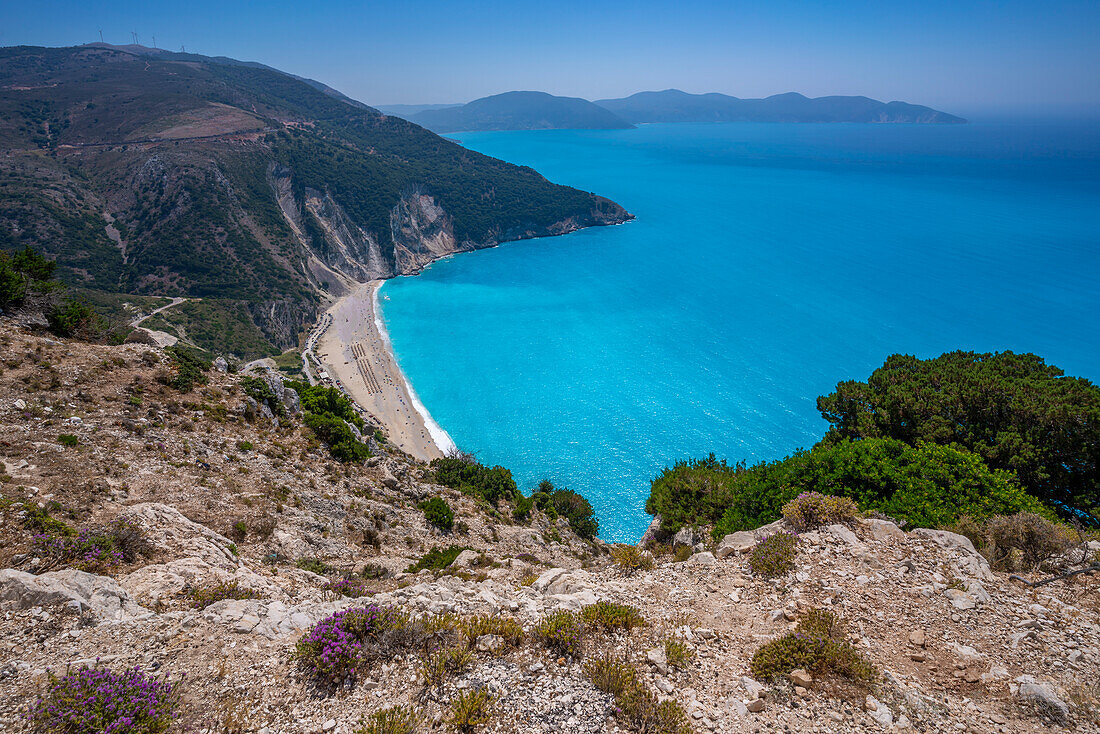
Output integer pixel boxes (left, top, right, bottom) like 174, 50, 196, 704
296, 604, 410, 686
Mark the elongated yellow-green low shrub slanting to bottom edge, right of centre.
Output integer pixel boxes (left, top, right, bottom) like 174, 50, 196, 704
584, 656, 692, 734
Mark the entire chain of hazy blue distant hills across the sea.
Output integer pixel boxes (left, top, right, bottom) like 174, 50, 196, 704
380, 89, 966, 132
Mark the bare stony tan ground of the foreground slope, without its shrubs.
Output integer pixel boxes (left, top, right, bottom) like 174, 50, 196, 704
0, 326, 1100, 734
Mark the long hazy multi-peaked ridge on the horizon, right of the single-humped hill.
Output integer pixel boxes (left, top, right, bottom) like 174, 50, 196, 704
596, 89, 966, 123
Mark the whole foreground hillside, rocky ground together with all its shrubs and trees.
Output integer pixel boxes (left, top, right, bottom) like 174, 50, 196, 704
0, 312, 1100, 734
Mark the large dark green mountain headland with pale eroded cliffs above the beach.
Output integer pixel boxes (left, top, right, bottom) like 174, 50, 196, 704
0, 46, 630, 351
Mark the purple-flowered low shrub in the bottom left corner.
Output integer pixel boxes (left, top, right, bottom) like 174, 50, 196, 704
29, 667, 179, 734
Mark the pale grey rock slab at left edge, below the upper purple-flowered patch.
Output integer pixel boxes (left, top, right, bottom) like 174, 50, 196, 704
0, 568, 153, 622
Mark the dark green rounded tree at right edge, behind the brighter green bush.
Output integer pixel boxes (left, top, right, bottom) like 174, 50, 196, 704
817, 351, 1100, 523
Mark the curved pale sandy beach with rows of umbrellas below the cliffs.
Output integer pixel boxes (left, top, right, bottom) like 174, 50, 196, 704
315, 281, 453, 461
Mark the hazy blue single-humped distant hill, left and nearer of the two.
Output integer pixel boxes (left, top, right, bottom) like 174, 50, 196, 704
409, 91, 633, 132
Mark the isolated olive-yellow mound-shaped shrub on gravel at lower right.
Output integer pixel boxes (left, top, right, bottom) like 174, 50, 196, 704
749, 610, 878, 688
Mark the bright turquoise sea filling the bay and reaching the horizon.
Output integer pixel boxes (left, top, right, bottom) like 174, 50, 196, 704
382, 122, 1100, 540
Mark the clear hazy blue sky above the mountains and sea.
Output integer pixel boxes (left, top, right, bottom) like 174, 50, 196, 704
0, 0, 1100, 114
